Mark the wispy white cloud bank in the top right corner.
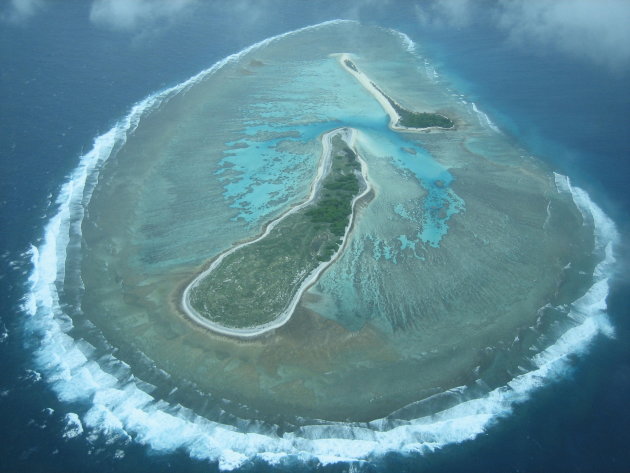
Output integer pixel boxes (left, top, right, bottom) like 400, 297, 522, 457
416, 0, 630, 68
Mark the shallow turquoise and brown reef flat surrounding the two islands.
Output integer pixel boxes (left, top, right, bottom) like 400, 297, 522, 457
68, 22, 601, 425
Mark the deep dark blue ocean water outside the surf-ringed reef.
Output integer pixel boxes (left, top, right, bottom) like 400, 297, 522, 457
0, 2, 630, 472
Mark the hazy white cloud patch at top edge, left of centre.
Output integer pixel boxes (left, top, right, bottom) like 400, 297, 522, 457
90, 0, 197, 31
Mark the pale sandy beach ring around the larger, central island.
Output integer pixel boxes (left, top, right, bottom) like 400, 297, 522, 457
180, 127, 372, 340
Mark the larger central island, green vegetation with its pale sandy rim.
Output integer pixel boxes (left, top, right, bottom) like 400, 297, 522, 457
182, 128, 371, 338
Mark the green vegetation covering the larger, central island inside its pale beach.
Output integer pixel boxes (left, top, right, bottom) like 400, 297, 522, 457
190, 131, 364, 328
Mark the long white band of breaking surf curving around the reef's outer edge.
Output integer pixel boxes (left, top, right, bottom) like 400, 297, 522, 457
24, 22, 616, 470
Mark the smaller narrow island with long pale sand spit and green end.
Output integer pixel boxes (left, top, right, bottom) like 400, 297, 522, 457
339, 53, 455, 131
